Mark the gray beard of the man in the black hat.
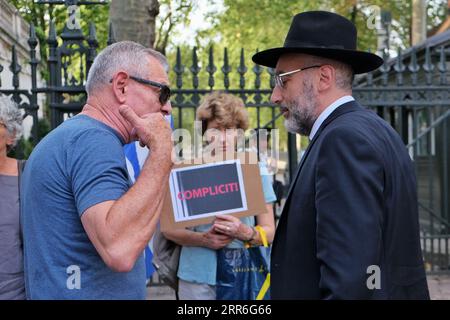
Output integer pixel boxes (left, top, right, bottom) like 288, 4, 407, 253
284, 79, 318, 136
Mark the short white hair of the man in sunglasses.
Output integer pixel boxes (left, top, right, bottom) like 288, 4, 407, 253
86, 41, 169, 96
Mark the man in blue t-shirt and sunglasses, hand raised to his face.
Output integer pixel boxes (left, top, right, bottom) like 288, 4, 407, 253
21, 41, 172, 299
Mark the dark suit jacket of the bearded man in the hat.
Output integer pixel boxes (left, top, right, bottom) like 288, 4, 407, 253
271, 101, 429, 299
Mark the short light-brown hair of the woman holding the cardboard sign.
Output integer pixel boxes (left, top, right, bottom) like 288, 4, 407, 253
197, 91, 248, 133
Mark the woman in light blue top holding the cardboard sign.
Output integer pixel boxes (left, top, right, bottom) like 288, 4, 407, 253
164, 92, 276, 300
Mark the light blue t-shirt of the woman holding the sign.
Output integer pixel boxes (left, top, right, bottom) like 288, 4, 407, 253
177, 163, 277, 286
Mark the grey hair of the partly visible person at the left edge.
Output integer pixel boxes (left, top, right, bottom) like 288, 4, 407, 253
0, 96, 23, 150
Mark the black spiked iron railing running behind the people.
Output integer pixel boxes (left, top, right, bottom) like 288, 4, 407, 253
0, 1, 450, 272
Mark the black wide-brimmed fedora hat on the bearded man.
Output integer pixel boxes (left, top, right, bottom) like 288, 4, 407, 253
252, 11, 383, 73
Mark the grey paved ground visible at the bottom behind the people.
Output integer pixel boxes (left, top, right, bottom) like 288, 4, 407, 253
147, 276, 450, 300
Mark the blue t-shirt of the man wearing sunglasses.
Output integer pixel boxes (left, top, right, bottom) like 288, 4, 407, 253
21, 115, 146, 299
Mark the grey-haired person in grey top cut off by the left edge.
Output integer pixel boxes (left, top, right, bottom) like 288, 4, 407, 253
0, 97, 25, 300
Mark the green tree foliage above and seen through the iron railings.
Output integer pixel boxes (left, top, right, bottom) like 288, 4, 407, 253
10, 0, 446, 152
